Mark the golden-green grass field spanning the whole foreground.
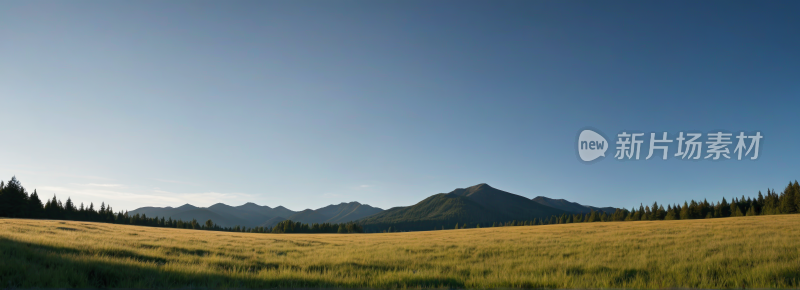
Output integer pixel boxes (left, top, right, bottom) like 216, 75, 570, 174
0, 215, 800, 288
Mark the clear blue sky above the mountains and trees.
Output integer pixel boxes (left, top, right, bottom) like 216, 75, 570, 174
0, 1, 800, 210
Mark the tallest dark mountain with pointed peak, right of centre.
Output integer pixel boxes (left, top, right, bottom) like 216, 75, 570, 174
358, 184, 565, 230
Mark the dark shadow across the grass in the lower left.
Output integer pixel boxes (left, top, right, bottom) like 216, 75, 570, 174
0, 238, 464, 289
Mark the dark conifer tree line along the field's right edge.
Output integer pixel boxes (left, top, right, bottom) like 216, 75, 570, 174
424, 180, 800, 232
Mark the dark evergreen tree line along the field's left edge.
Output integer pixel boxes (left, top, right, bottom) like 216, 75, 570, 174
0, 177, 364, 233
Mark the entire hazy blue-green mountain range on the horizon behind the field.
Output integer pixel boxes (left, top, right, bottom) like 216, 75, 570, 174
130, 183, 616, 231
